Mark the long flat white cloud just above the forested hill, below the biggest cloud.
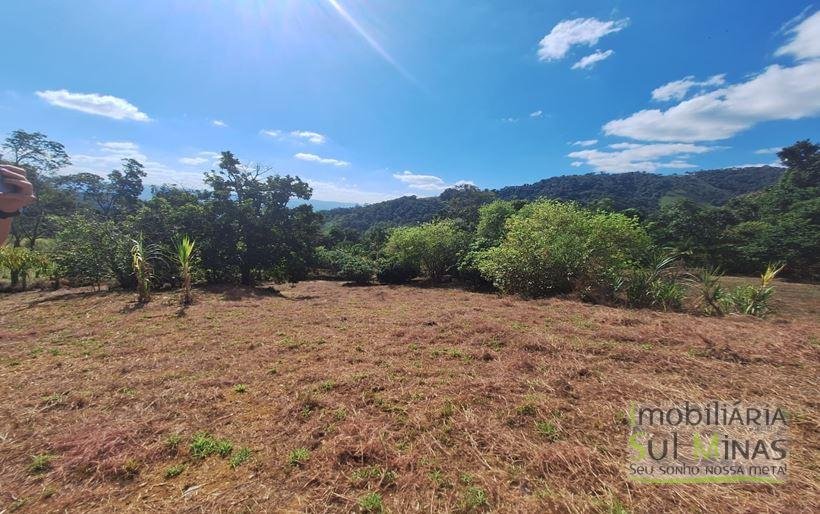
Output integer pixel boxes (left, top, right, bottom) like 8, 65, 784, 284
568, 143, 716, 173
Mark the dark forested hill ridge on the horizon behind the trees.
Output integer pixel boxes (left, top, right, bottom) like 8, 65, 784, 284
322, 166, 785, 231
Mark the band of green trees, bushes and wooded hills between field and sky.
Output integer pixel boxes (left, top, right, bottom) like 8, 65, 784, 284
0, 127, 820, 314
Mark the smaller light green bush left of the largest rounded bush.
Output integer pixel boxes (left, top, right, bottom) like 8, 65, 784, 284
384, 220, 470, 281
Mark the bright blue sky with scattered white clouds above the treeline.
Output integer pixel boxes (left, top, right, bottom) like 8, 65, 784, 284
0, 0, 820, 203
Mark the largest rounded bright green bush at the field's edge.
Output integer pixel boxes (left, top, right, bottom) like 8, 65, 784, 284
478, 200, 650, 297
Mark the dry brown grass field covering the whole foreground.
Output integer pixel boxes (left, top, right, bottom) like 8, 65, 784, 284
0, 282, 820, 512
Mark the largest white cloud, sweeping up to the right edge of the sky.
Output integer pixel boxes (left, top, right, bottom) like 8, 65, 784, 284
603, 13, 820, 142
